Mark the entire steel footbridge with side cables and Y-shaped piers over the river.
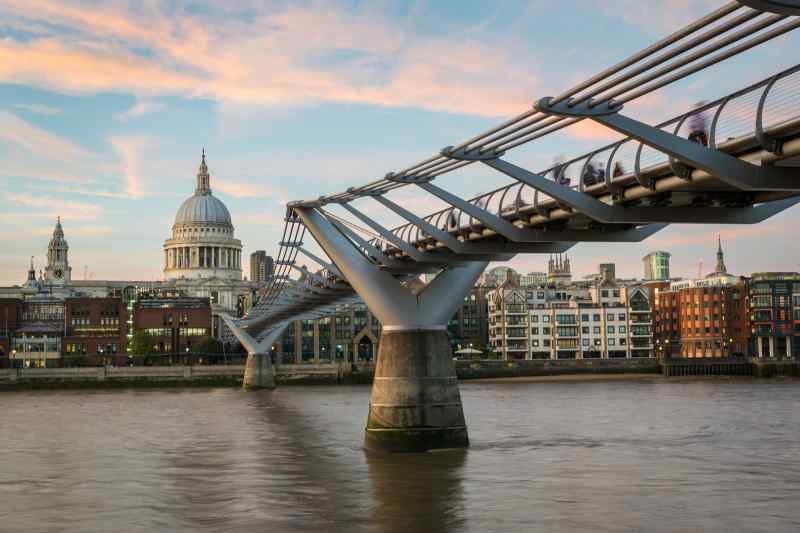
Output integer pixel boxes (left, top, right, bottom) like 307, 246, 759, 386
223, 0, 800, 451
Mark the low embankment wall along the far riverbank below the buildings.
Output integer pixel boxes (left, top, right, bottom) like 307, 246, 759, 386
0, 359, 800, 391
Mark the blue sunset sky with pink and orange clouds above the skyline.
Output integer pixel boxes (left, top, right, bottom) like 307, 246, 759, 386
0, 0, 800, 285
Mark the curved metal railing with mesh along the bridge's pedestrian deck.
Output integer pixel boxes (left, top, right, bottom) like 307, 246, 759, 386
382, 61, 800, 249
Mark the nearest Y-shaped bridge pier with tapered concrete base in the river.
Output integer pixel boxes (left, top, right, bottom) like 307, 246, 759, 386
295, 207, 487, 452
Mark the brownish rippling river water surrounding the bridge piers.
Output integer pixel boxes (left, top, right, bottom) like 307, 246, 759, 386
0, 379, 800, 532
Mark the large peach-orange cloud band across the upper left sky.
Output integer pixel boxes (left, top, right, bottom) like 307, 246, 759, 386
0, 0, 537, 116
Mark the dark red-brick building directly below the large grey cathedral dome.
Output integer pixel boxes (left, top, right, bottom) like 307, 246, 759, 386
133, 298, 211, 354
